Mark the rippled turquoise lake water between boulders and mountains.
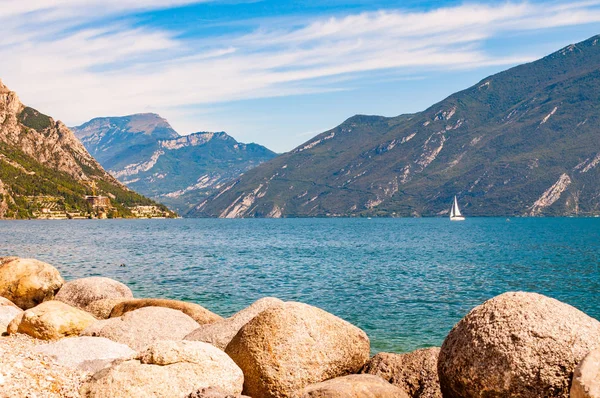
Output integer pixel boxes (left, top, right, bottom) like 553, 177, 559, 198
0, 218, 600, 352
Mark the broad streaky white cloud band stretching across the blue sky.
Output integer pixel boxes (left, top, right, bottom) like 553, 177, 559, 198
0, 0, 600, 131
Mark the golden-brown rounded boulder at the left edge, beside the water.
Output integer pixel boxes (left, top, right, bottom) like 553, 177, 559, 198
0, 257, 64, 310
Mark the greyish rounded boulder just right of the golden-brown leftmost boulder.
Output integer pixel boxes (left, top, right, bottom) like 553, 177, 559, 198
55, 276, 133, 309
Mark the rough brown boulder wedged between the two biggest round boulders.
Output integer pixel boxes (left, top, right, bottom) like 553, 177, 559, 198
362, 347, 442, 398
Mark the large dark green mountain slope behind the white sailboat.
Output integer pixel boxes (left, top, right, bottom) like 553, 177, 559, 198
192, 36, 600, 217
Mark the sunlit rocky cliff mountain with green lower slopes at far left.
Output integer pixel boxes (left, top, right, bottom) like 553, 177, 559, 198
0, 81, 174, 218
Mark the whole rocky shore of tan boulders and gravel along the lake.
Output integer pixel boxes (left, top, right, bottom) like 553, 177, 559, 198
0, 257, 600, 398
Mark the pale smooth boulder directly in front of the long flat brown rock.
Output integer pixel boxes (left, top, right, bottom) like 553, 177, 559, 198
81, 307, 198, 350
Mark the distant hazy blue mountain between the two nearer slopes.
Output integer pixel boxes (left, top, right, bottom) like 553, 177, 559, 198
73, 114, 276, 214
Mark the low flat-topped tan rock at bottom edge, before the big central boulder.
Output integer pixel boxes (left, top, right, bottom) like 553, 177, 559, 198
298, 374, 409, 398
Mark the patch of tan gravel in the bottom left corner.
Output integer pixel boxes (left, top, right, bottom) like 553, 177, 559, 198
0, 334, 88, 398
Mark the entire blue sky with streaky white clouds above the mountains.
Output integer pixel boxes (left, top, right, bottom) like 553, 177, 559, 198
0, 0, 600, 152
